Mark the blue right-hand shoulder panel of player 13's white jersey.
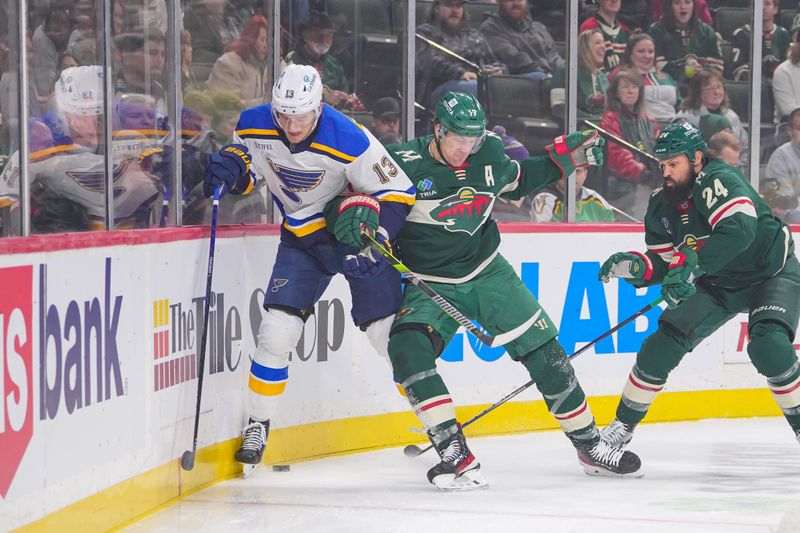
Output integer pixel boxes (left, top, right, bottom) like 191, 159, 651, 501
311, 104, 380, 163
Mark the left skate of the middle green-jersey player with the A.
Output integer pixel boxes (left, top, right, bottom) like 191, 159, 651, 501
428, 427, 489, 492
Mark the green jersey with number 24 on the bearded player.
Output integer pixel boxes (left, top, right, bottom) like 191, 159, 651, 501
644, 160, 794, 289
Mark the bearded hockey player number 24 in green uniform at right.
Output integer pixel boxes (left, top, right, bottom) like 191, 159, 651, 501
600, 122, 800, 458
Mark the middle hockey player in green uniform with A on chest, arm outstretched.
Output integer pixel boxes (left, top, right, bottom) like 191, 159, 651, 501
376, 92, 640, 490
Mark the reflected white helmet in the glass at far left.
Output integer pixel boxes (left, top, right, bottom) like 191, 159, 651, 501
55, 65, 105, 116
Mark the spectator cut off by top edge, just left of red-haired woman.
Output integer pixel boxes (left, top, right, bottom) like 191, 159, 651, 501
183, 0, 238, 80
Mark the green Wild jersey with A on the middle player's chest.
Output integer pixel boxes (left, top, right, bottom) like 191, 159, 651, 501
387, 133, 561, 283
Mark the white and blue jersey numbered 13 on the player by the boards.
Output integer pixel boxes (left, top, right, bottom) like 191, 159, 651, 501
233, 104, 416, 244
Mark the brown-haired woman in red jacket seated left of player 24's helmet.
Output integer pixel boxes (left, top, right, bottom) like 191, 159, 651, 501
600, 70, 663, 219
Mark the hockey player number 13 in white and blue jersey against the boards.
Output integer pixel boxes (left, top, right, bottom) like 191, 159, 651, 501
205, 65, 416, 465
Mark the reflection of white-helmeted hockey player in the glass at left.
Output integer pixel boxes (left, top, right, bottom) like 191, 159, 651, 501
0, 65, 159, 234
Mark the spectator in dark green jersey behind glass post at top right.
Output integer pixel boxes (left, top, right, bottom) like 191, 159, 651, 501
731, 0, 791, 81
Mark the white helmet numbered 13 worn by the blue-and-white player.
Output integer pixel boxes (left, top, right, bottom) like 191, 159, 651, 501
272, 64, 322, 123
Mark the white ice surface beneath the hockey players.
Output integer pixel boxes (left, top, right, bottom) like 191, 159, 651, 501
126, 418, 800, 533
